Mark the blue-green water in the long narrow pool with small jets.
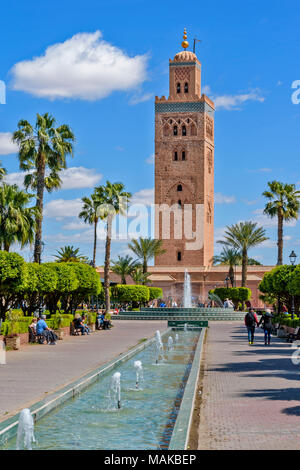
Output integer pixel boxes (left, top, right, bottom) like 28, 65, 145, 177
0, 329, 203, 450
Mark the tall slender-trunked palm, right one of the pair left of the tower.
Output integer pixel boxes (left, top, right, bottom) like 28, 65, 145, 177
96, 181, 131, 312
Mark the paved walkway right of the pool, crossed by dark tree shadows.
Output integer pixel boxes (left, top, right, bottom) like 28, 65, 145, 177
198, 322, 300, 450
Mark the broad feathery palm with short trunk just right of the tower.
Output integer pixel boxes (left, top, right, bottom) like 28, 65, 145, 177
217, 222, 268, 287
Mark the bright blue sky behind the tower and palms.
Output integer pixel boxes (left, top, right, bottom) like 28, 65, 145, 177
0, 0, 300, 264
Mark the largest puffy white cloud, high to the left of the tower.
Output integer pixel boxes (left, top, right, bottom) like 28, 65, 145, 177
12, 31, 147, 101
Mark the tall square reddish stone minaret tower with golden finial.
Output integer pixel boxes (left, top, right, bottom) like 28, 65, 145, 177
155, 31, 214, 268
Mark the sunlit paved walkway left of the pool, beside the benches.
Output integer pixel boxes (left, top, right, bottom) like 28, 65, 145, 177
0, 320, 167, 421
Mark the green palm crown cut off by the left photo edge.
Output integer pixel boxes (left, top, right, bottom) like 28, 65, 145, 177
0, 183, 37, 251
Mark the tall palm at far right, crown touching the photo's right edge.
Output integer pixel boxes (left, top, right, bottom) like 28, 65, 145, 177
263, 181, 300, 265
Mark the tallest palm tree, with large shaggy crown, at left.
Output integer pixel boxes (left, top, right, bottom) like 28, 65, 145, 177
13, 113, 75, 263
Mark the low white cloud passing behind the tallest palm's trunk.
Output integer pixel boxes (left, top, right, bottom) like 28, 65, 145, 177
5, 166, 102, 189
